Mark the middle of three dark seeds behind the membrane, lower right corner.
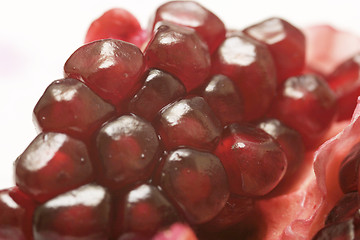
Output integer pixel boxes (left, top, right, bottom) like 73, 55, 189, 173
325, 192, 360, 225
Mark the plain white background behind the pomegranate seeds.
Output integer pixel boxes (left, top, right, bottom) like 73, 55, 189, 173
0, 0, 360, 189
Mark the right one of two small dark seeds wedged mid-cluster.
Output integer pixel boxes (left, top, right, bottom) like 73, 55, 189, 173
202, 74, 244, 126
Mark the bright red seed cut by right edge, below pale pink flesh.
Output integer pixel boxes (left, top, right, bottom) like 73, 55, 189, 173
327, 53, 360, 121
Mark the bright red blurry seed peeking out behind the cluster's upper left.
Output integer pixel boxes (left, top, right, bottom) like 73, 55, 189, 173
85, 8, 147, 48
